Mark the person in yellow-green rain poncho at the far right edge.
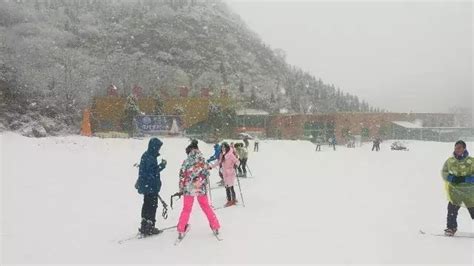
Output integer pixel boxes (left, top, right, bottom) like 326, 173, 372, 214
441, 140, 474, 236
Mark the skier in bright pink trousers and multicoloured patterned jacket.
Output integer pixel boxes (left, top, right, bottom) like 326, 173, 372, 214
178, 140, 220, 239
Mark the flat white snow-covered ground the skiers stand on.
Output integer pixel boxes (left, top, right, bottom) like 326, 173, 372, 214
0, 133, 474, 265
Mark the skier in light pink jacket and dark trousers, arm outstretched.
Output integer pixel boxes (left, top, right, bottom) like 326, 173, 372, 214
210, 142, 239, 207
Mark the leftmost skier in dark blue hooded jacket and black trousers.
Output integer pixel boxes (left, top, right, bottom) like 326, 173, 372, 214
135, 138, 166, 236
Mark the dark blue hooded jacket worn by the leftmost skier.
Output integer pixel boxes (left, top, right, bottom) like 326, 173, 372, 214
137, 138, 165, 194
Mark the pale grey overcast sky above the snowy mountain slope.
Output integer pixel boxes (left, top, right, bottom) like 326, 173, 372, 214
227, 0, 474, 112
